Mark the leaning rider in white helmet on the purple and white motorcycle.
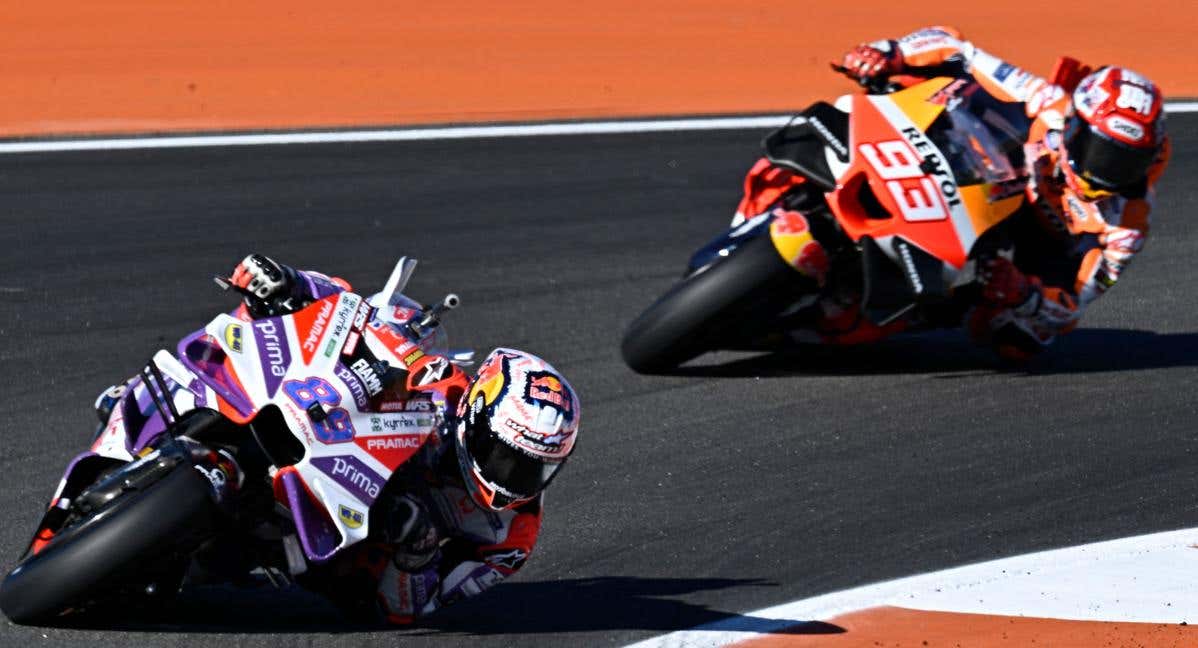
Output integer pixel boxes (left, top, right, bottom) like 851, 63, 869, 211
97, 254, 579, 624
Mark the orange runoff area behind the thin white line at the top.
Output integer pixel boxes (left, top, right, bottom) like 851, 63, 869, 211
0, 0, 1198, 137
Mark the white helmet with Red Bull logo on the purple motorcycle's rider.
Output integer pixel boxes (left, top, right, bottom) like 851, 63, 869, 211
456, 349, 580, 510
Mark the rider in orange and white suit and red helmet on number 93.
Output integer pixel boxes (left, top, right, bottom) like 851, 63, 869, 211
738, 26, 1169, 357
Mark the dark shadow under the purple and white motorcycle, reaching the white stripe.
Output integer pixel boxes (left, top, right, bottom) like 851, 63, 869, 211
39, 576, 845, 636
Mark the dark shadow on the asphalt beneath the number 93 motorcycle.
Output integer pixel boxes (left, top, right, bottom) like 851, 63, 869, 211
671, 328, 1198, 378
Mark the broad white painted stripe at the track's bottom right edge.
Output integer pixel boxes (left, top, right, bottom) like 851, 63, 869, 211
633, 528, 1198, 648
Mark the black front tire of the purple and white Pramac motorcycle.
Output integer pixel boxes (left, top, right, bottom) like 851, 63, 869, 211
0, 464, 216, 625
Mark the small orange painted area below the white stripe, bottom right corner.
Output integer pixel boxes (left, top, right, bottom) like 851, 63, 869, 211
736, 607, 1198, 648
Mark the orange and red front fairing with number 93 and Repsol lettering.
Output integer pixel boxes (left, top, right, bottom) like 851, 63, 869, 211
827, 78, 1021, 270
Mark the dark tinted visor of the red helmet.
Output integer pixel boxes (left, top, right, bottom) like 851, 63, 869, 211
1065, 115, 1156, 189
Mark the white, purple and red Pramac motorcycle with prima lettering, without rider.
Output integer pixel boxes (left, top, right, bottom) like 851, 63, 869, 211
0, 258, 472, 624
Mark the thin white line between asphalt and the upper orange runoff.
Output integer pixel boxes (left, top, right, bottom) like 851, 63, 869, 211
0, 102, 1198, 155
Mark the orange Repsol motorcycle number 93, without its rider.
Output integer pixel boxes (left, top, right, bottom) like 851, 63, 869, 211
622, 78, 1029, 373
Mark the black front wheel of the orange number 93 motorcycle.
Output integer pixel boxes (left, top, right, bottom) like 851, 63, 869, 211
621, 234, 817, 374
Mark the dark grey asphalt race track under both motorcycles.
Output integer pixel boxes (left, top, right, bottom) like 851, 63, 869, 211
0, 115, 1198, 647
